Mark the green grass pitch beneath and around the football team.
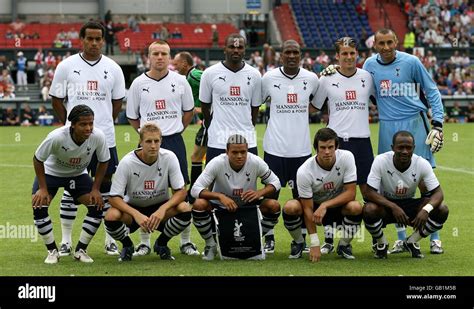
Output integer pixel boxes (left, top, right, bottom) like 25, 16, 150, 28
0, 124, 474, 276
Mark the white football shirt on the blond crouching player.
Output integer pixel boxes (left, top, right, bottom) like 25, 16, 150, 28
110, 148, 184, 207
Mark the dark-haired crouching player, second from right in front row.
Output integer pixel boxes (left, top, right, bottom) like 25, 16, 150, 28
283, 128, 362, 262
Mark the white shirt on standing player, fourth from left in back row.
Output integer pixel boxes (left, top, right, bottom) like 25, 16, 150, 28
262, 67, 319, 158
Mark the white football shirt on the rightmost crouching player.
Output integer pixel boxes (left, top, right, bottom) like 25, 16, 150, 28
367, 151, 439, 199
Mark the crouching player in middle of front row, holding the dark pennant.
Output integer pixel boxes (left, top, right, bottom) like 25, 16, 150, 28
191, 134, 281, 261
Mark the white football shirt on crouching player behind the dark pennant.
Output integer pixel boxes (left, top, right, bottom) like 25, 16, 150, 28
191, 152, 281, 207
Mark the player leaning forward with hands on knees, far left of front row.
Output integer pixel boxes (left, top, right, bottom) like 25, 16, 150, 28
32, 105, 110, 264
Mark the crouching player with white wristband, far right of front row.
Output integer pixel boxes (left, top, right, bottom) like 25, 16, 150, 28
363, 131, 449, 259
